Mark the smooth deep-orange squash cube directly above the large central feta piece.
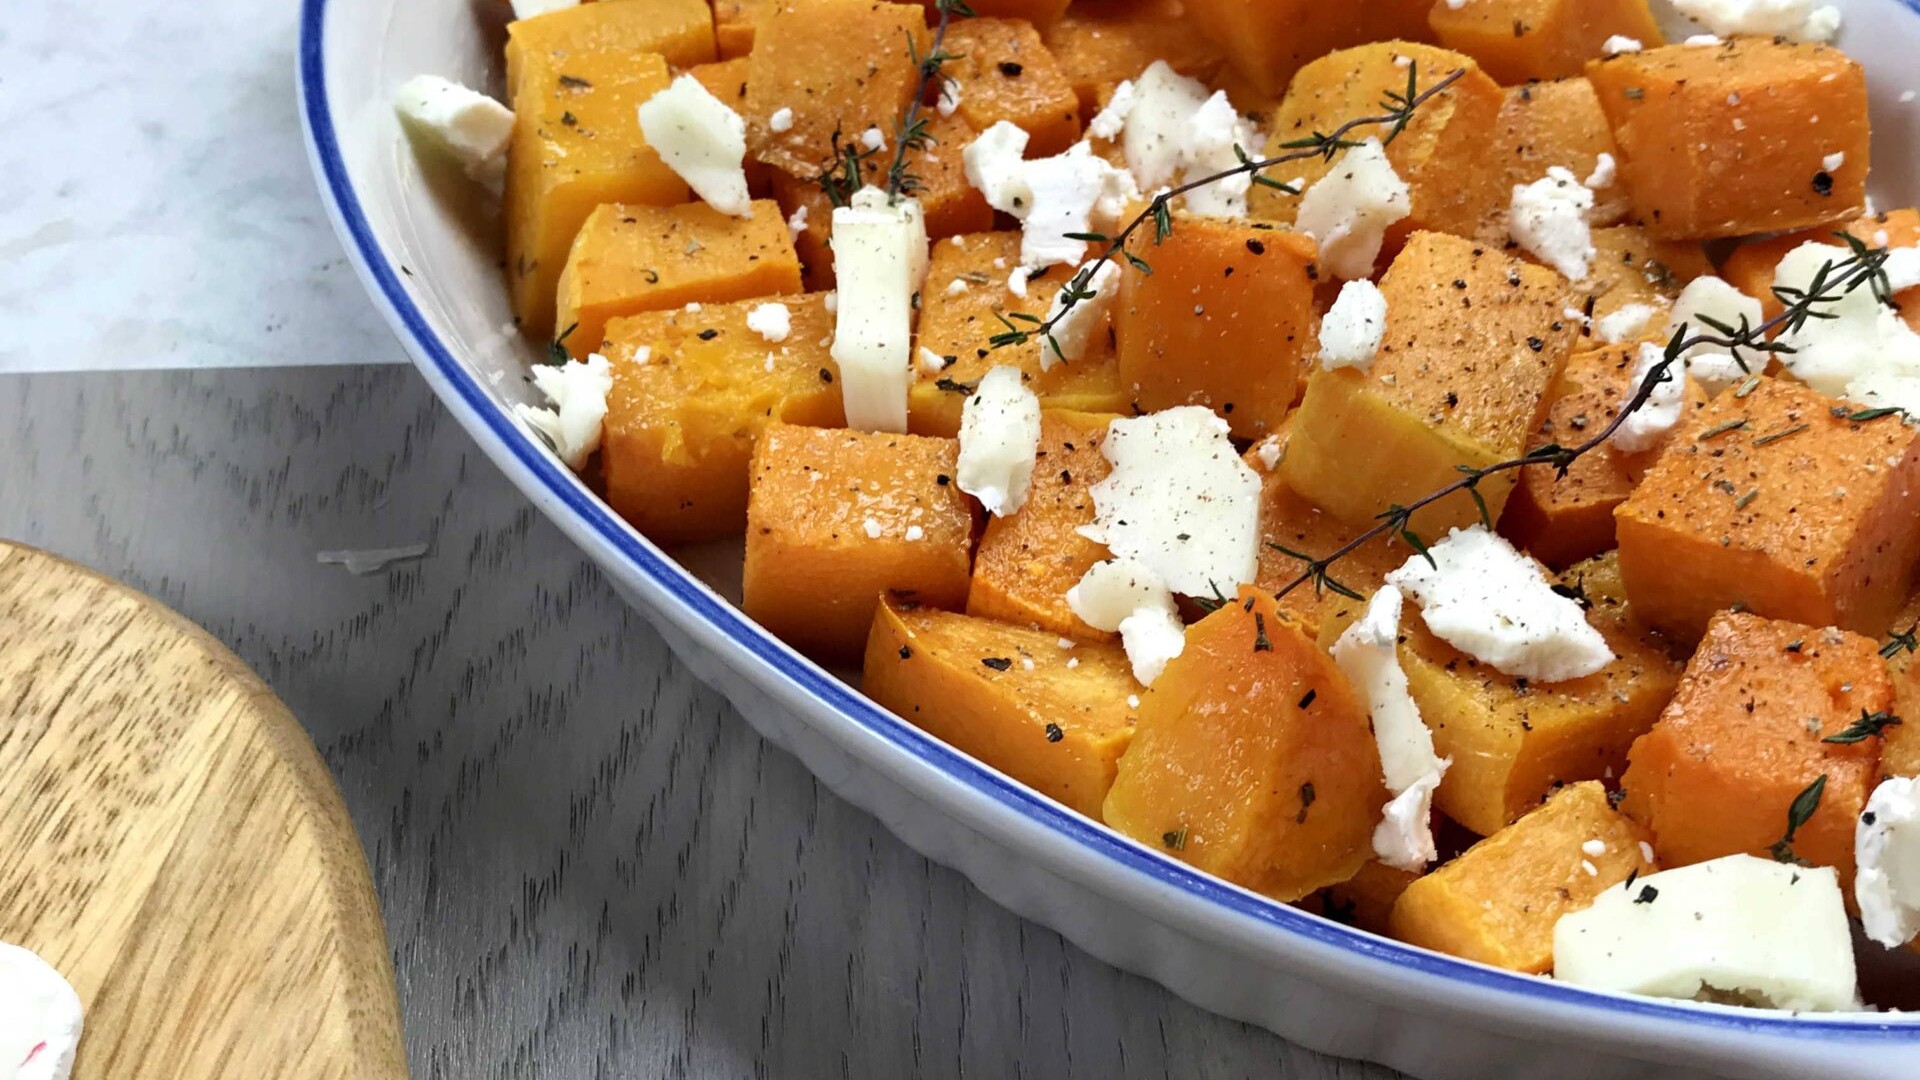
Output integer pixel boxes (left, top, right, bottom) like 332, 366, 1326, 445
1114, 217, 1319, 438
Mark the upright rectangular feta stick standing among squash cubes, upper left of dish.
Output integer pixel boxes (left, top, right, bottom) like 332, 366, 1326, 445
831, 186, 927, 432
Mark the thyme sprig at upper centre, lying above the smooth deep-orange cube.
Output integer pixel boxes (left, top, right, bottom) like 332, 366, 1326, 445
989, 63, 1467, 356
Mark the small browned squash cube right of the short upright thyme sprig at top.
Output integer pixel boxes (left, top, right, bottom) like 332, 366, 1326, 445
941, 17, 1081, 158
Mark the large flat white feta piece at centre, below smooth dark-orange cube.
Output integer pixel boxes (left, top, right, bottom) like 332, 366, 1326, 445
1091, 405, 1260, 596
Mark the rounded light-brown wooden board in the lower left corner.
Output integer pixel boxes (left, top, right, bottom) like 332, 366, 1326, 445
0, 544, 407, 1080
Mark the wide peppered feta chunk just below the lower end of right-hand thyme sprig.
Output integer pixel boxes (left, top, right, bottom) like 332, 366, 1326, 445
1386, 525, 1613, 682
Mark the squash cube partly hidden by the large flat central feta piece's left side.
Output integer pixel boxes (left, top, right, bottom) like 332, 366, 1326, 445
966, 409, 1116, 642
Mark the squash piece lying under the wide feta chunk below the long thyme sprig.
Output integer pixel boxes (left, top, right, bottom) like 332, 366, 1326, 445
1400, 555, 1680, 836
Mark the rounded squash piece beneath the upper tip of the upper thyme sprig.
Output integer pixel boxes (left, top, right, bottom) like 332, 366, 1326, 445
1248, 40, 1513, 250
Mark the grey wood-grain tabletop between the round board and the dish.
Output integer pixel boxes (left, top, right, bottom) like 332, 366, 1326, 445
0, 369, 1394, 1080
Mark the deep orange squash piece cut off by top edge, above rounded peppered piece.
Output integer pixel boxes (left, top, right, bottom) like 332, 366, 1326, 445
1187, 0, 1434, 94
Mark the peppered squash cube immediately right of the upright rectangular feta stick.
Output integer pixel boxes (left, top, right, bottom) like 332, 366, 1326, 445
906, 233, 1131, 436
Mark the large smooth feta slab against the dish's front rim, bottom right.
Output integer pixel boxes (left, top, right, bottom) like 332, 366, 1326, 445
1553, 855, 1857, 1011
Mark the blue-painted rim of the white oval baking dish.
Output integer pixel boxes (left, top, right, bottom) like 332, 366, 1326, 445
298, 0, 1920, 1042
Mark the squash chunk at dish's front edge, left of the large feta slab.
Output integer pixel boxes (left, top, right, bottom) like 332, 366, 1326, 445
1388, 782, 1657, 974
